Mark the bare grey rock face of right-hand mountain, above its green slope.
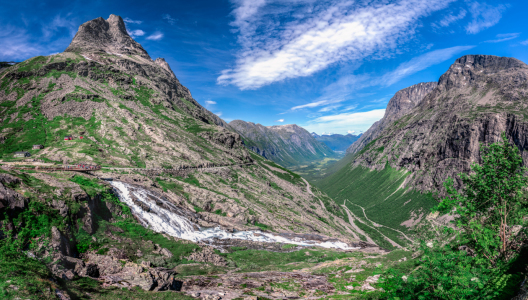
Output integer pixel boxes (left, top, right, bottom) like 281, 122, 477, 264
344, 55, 528, 191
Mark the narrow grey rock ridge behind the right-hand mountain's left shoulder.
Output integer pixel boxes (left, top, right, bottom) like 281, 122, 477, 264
346, 82, 437, 154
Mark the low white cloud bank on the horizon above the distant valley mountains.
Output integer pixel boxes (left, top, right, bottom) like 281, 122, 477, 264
303, 109, 385, 133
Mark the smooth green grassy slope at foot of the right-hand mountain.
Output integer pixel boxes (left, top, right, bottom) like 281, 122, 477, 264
317, 156, 436, 243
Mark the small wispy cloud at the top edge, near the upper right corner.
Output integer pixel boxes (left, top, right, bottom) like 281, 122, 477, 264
466, 1, 508, 34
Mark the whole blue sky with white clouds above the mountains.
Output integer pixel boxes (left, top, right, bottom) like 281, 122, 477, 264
0, 0, 528, 134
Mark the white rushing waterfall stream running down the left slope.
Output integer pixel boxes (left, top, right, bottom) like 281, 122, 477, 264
110, 181, 358, 250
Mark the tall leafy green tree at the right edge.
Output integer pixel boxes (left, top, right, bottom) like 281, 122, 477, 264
437, 133, 528, 263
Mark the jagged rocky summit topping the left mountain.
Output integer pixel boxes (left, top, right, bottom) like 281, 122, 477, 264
64, 15, 150, 59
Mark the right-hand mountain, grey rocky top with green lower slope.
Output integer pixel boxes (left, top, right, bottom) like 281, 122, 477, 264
319, 55, 528, 248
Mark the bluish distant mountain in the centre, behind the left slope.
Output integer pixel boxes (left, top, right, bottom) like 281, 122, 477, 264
229, 120, 335, 167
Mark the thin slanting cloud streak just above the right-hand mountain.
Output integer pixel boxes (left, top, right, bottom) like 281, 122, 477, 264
382, 46, 475, 86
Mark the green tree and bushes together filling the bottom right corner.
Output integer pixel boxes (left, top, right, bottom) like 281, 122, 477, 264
381, 134, 528, 299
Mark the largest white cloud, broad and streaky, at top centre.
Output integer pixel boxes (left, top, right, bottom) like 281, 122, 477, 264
217, 0, 454, 90
